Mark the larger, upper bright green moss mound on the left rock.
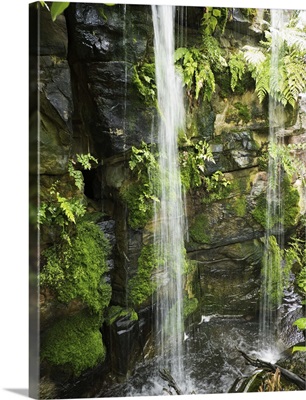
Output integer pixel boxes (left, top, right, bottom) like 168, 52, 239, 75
40, 221, 111, 312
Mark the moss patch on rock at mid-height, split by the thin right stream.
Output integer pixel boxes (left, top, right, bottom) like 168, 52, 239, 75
252, 177, 300, 229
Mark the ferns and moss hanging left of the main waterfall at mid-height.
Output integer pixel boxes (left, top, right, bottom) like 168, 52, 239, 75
121, 142, 160, 229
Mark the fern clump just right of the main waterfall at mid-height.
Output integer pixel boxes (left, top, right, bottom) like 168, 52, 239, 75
179, 140, 215, 190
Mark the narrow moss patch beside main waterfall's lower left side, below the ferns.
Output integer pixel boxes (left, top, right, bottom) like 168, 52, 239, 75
129, 245, 159, 306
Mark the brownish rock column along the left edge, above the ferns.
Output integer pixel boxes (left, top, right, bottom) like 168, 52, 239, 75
33, 9, 73, 175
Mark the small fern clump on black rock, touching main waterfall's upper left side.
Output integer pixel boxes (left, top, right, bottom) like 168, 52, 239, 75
133, 63, 157, 106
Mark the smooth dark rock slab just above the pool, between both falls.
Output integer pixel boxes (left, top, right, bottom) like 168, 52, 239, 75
191, 240, 262, 317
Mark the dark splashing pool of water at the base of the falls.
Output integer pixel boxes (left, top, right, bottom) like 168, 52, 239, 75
98, 317, 270, 397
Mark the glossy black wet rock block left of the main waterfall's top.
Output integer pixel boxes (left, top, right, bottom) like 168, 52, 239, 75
67, 4, 156, 157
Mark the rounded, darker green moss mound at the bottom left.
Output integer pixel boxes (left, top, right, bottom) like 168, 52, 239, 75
41, 312, 105, 376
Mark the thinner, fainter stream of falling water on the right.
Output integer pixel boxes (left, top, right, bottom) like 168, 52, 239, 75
259, 10, 284, 354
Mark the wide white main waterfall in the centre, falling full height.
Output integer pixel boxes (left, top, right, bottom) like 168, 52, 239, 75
152, 6, 185, 383
